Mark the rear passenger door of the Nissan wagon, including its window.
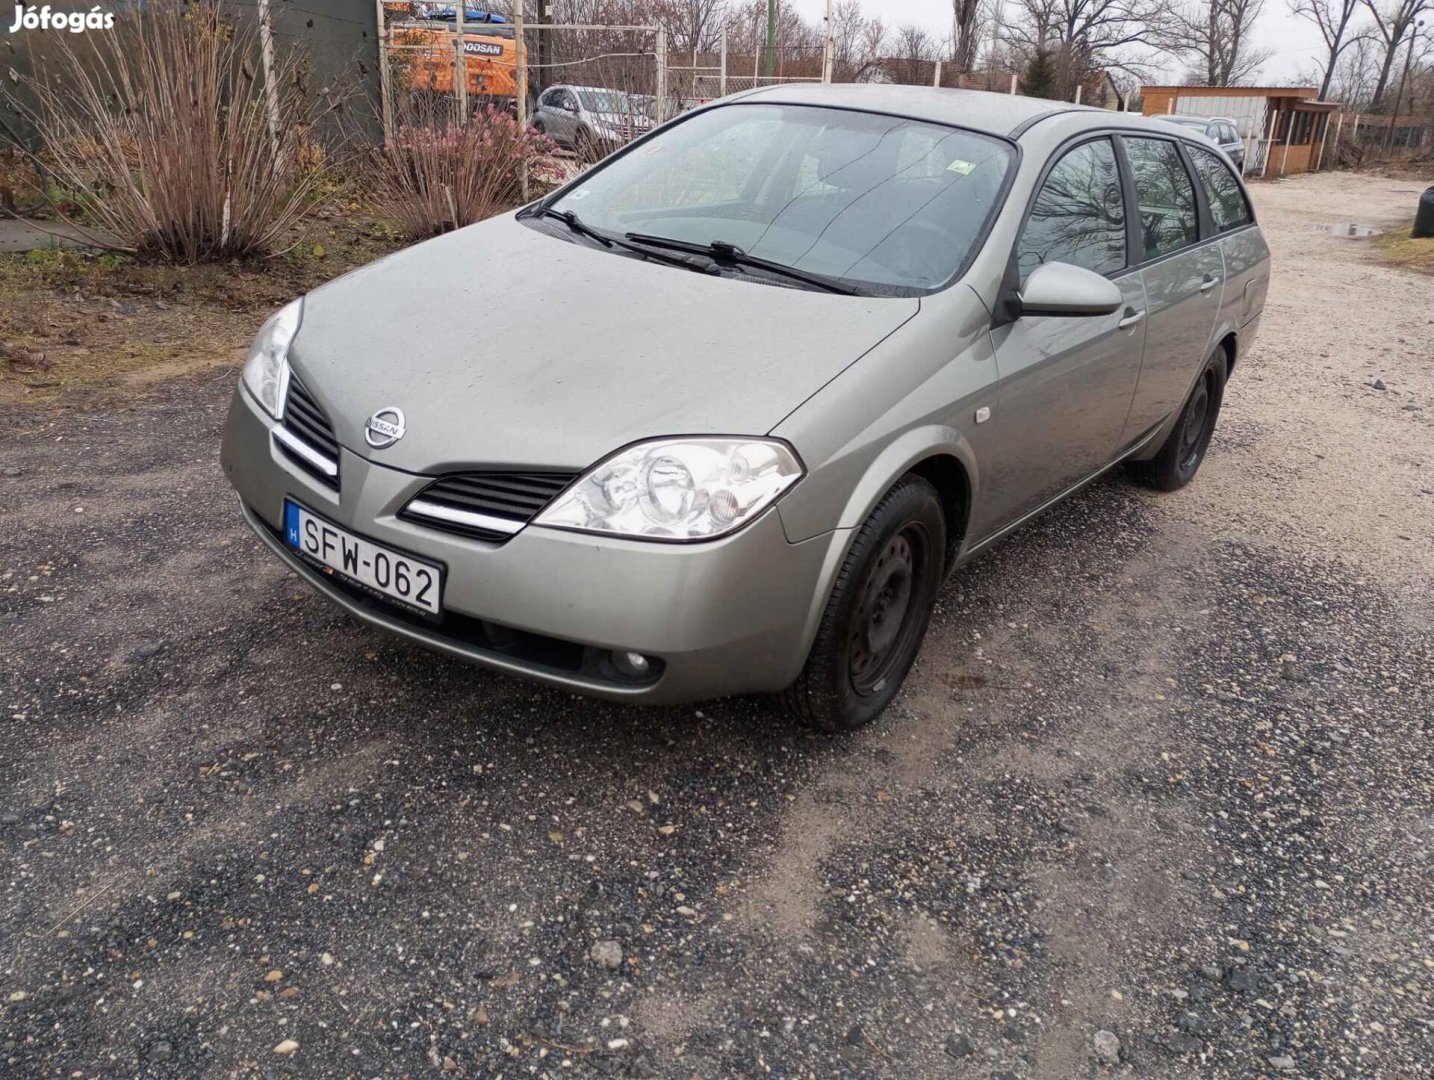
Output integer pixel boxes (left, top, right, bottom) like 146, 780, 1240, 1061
1120, 135, 1225, 446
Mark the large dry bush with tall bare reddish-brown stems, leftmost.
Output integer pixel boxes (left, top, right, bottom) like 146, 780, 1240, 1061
10, 0, 338, 264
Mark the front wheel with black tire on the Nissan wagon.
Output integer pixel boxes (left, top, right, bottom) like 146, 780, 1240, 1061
780, 473, 946, 731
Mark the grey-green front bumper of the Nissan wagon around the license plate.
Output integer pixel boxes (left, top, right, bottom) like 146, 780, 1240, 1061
221, 390, 845, 704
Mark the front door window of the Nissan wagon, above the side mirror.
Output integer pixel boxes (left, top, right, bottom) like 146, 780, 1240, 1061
1017, 139, 1126, 281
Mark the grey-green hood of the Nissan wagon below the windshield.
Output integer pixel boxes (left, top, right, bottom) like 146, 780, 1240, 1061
290, 215, 919, 472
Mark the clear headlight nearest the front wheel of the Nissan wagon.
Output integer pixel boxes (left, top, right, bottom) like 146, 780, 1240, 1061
533, 439, 802, 541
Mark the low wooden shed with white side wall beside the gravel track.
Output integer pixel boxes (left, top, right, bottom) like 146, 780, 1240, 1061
1140, 86, 1339, 176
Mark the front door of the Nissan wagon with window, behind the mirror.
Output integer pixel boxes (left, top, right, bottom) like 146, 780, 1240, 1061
985, 135, 1146, 529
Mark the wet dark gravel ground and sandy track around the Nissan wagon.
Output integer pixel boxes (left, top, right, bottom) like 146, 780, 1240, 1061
0, 175, 1434, 1080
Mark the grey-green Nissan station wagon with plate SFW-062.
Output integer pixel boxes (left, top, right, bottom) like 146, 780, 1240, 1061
222, 85, 1269, 729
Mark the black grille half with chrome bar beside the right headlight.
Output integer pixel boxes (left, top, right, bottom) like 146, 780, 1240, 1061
399, 472, 576, 541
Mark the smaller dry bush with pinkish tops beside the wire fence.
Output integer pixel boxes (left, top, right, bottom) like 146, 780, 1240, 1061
371, 98, 556, 240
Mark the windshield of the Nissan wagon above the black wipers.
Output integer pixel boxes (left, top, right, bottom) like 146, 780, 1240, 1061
552, 103, 1014, 294
